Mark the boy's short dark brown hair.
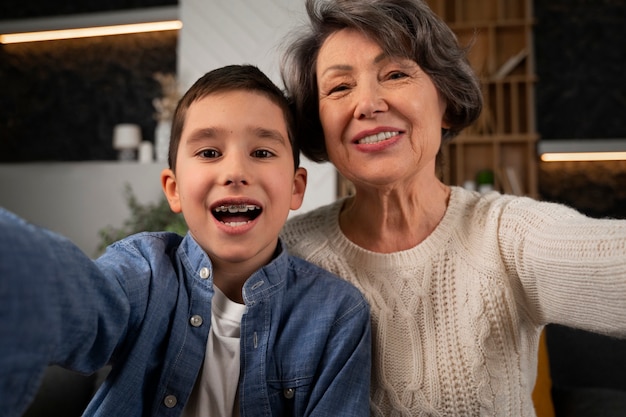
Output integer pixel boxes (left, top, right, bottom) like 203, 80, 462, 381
168, 65, 300, 172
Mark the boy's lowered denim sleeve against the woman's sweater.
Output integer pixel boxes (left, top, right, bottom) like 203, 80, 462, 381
306, 289, 371, 417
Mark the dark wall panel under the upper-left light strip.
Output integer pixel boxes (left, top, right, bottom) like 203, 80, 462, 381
0, 31, 178, 162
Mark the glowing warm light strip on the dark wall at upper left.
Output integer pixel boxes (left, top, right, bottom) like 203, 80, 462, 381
0, 20, 183, 44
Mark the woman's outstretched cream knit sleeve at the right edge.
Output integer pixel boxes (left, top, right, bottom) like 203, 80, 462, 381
498, 194, 626, 337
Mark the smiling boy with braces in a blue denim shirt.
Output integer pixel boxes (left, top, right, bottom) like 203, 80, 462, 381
0, 66, 370, 417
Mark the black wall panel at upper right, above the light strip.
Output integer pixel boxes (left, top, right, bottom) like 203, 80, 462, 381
534, 0, 626, 139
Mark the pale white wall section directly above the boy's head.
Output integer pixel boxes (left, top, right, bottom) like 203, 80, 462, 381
177, 0, 304, 89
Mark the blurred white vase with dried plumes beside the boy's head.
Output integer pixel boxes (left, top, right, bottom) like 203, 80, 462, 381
152, 72, 180, 162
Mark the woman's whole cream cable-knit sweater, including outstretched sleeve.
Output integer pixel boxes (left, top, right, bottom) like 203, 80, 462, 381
282, 187, 626, 417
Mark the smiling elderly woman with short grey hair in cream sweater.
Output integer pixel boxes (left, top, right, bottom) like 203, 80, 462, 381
282, 0, 626, 416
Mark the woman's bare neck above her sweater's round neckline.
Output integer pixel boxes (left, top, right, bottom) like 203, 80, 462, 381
339, 182, 450, 253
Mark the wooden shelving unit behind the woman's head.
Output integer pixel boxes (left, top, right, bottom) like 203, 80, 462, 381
428, 0, 538, 197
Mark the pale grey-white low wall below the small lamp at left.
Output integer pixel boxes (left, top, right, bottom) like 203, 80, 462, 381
0, 161, 164, 256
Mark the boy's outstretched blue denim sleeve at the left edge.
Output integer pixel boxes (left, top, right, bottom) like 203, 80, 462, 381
0, 208, 129, 417
